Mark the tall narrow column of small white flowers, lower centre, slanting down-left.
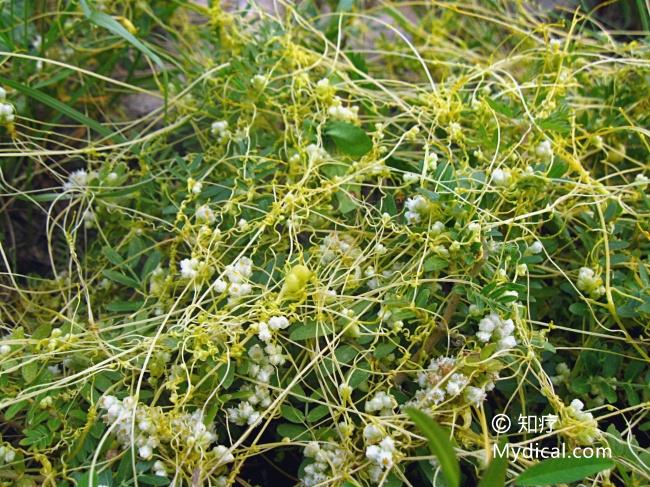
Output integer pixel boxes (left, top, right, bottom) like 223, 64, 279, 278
228, 344, 286, 426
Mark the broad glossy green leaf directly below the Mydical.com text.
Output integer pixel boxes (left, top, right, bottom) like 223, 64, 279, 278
515, 458, 615, 486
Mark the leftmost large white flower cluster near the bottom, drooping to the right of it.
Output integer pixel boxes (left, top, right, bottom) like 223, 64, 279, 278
99, 396, 160, 460
